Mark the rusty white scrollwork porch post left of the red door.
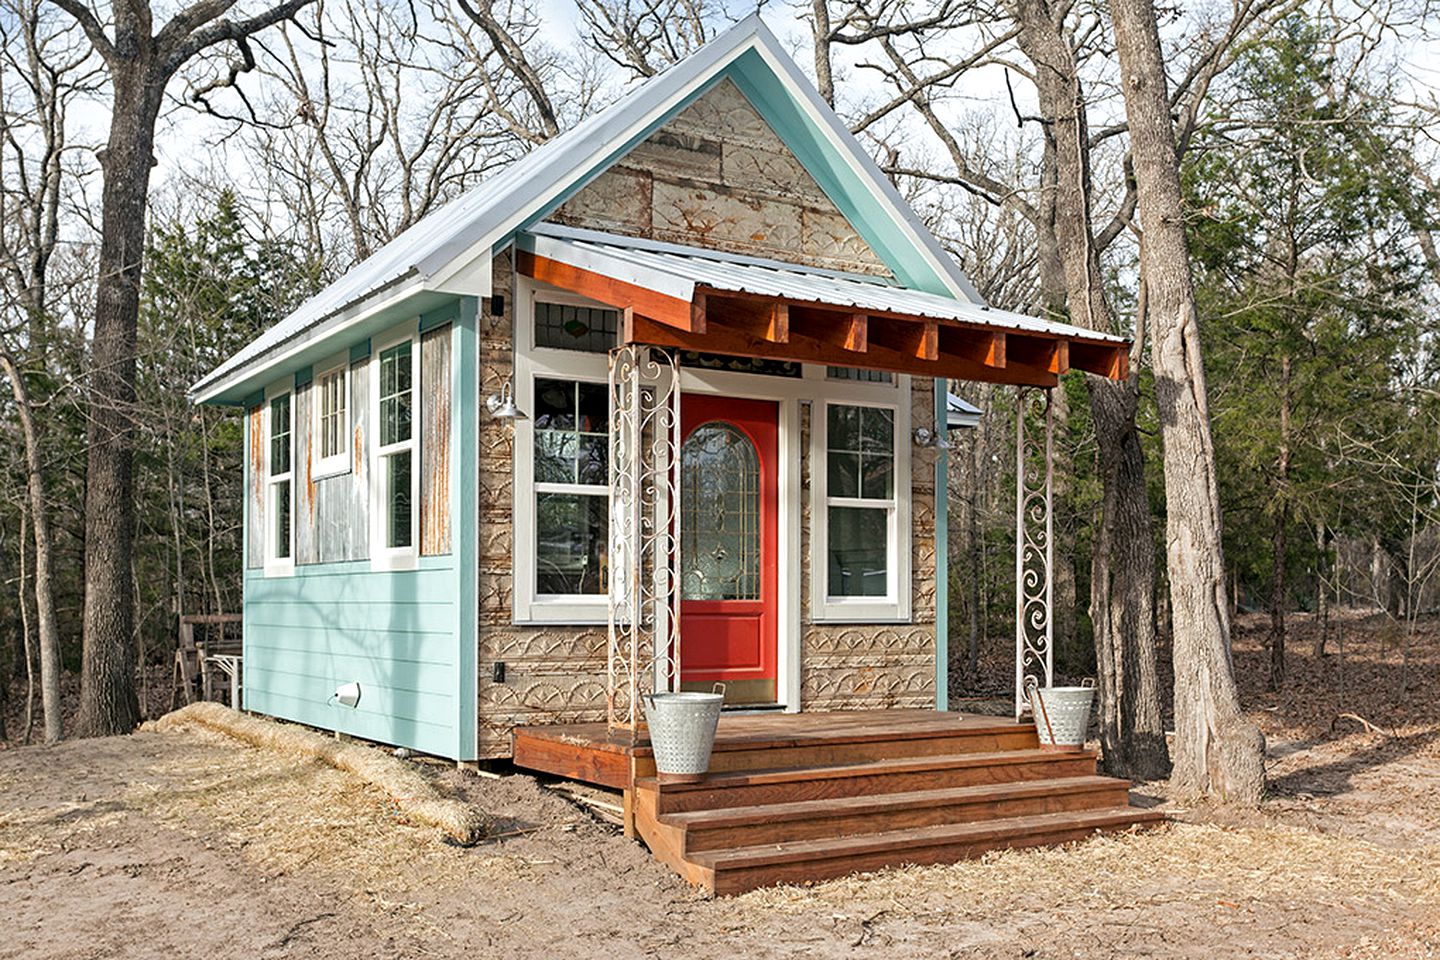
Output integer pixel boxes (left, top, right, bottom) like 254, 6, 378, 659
605, 344, 680, 734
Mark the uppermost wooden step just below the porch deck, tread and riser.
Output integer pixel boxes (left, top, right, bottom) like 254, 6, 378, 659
635, 750, 1094, 813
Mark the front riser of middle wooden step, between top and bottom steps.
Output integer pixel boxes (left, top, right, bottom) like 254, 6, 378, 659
683, 784, 1129, 856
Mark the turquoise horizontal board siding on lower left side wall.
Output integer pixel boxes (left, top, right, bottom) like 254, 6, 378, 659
243, 557, 457, 757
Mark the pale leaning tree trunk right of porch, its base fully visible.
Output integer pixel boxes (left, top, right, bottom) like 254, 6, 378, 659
1110, 0, 1264, 803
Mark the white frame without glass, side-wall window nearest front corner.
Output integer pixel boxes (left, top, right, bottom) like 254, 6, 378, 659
367, 320, 422, 570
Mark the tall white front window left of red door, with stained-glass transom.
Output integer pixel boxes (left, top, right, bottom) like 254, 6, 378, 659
513, 284, 619, 623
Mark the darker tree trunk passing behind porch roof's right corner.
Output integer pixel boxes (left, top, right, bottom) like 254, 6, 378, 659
1014, 0, 1169, 780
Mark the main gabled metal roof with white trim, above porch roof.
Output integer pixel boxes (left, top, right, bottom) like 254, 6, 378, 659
190, 14, 979, 402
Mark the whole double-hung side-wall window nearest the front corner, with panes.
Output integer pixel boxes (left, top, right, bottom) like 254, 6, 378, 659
370, 324, 420, 570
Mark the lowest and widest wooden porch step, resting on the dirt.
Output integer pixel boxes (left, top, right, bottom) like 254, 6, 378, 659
685, 807, 1165, 894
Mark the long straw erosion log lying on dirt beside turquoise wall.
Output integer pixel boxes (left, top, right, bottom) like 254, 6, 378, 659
154, 702, 488, 845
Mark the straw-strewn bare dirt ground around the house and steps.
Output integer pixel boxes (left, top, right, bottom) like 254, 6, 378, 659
0, 617, 1440, 960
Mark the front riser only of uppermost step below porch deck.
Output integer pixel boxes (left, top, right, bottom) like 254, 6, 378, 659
657, 754, 1094, 813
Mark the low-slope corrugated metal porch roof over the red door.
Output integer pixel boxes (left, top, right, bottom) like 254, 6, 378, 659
518, 223, 1125, 344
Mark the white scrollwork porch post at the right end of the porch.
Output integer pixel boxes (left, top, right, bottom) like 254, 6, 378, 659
1015, 387, 1056, 720
